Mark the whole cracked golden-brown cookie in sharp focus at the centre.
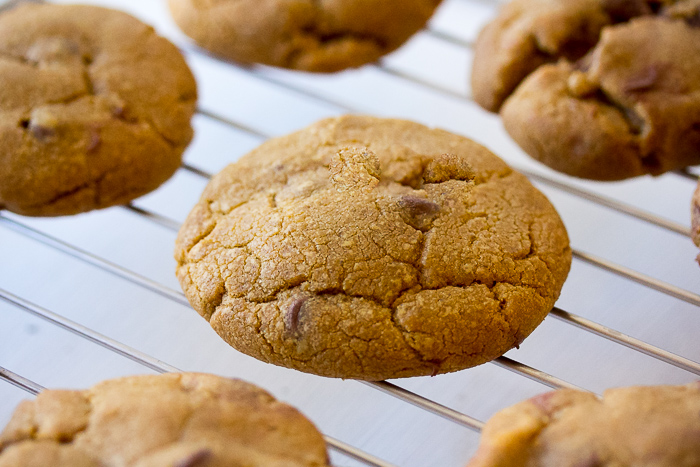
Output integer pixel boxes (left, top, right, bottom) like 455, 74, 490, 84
175, 116, 571, 380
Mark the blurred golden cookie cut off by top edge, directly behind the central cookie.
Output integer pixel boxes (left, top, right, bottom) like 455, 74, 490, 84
168, 0, 440, 72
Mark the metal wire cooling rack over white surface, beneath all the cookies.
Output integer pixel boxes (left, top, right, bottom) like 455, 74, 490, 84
0, 0, 700, 466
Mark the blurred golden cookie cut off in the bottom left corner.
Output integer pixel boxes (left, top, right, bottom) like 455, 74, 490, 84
0, 373, 329, 467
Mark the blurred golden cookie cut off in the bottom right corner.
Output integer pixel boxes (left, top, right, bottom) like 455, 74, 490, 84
468, 383, 700, 467
